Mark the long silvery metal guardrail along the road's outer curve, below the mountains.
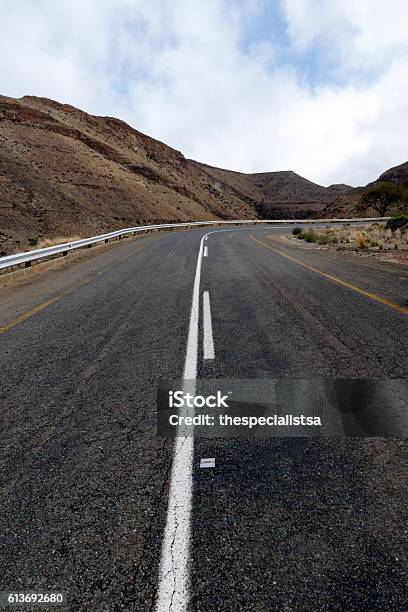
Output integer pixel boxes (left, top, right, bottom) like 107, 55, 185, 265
0, 217, 390, 269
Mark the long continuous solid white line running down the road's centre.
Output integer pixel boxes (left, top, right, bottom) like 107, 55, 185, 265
156, 228, 247, 612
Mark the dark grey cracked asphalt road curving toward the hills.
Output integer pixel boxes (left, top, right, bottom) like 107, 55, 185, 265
0, 227, 408, 612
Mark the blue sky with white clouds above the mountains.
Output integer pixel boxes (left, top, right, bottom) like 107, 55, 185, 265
0, 0, 408, 185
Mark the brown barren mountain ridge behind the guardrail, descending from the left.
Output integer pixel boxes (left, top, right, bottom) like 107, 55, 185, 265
0, 96, 398, 254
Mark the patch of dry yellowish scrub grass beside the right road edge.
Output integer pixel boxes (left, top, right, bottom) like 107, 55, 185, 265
297, 223, 408, 251
